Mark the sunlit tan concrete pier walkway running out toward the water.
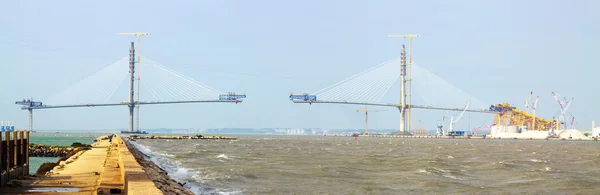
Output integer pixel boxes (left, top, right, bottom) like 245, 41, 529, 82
0, 135, 176, 194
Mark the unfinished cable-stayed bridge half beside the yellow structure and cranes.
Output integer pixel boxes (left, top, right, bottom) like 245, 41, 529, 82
289, 45, 498, 134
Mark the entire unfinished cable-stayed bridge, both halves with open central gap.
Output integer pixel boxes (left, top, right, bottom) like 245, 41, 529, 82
16, 38, 524, 133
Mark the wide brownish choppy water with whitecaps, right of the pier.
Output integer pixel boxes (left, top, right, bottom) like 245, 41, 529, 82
137, 136, 600, 194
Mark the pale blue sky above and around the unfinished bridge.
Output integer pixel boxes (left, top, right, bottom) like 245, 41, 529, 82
0, 0, 600, 129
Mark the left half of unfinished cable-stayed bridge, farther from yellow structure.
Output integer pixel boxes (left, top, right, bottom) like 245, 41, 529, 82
15, 42, 246, 132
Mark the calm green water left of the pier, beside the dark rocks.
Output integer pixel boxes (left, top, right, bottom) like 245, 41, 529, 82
29, 133, 100, 175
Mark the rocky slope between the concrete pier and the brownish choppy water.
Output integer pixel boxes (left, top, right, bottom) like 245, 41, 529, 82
124, 139, 194, 195
